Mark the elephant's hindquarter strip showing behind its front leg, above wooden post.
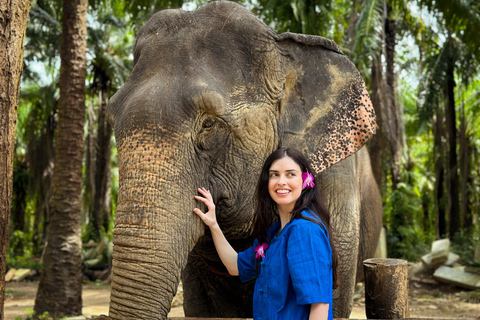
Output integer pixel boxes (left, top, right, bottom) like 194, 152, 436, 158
356, 147, 383, 282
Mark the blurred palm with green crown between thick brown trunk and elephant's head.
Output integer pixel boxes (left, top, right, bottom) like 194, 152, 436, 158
85, 11, 133, 239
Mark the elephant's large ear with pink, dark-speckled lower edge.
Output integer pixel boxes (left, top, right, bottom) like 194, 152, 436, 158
276, 33, 376, 173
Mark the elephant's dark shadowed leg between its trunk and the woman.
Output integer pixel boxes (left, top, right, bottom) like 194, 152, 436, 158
182, 244, 254, 318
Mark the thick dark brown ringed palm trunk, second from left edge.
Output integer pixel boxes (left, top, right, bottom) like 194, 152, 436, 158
35, 0, 88, 317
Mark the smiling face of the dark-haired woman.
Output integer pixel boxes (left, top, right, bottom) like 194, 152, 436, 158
268, 157, 303, 213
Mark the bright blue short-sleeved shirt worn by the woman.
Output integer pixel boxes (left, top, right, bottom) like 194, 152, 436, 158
237, 211, 333, 320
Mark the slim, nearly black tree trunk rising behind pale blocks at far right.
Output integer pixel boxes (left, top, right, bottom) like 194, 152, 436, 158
445, 41, 460, 237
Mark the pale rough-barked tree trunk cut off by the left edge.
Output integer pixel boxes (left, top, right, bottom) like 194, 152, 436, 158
0, 0, 31, 320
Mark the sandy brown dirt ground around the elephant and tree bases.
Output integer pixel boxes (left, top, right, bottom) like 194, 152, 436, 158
5, 279, 480, 320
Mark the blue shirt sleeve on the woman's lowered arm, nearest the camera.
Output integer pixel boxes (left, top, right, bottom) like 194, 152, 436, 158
287, 220, 333, 307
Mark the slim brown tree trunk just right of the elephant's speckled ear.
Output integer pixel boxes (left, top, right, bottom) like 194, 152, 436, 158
385, 3, 403, 190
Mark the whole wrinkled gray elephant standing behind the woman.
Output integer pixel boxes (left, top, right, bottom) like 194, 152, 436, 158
107, 2, 382, 319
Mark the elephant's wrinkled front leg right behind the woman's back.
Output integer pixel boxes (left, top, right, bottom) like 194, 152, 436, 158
320, 157, 360, 318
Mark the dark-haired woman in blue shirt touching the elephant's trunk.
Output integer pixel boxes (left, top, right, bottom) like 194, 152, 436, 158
194, 148, 338, 320
